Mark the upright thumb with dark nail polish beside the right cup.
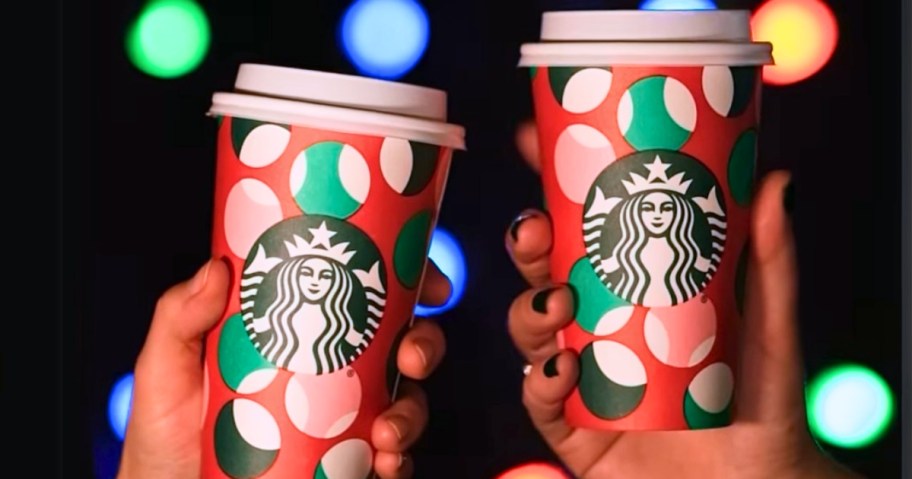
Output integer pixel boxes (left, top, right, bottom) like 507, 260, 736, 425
739, 172, 805, 423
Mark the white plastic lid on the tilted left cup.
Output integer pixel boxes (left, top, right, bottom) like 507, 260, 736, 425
209, 63, 465, 149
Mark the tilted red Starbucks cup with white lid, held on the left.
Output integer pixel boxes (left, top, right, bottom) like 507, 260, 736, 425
202, 64, 464, 479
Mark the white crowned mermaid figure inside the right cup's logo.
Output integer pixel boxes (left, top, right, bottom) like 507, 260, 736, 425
587, 158, 725, 307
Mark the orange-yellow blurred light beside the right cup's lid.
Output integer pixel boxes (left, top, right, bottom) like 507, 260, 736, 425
751, 0, 839, 85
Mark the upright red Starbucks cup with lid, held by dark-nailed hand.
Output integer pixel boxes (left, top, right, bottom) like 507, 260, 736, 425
520, 11, 771, 430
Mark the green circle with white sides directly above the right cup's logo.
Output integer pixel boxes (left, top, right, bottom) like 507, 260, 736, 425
618, 76, 697, 151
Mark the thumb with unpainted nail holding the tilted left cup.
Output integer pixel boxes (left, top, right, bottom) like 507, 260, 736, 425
133, 260, 230, 424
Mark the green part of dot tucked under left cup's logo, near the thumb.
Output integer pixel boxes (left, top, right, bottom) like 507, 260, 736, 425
218, 314, 275, 391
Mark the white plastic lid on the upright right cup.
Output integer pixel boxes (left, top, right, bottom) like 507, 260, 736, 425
519, 10, 773, 67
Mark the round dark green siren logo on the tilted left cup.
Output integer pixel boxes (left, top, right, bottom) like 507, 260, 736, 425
240, 215, 386, 374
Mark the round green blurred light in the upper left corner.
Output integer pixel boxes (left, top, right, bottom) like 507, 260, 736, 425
126, 0, 210, 78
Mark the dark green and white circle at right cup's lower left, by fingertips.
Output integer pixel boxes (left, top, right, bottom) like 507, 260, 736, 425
579, 340, 647, 420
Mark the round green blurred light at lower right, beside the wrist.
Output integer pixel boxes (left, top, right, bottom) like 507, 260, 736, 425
807, 364, 894, 448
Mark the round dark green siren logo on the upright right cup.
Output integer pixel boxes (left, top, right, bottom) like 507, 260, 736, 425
583, 154, 727, 307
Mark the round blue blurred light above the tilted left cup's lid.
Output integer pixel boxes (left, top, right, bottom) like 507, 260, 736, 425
340, 0, 430, 80
